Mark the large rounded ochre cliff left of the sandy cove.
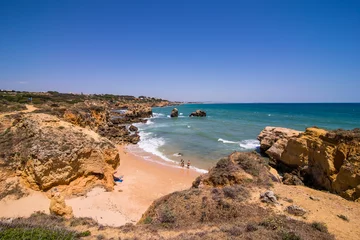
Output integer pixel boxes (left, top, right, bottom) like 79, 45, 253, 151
0, 113, 120, 193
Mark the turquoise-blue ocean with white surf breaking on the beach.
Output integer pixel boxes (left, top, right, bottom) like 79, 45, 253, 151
128, 103, 360, 172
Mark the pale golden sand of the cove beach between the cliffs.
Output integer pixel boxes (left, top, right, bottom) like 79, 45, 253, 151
0, 146, 200, 226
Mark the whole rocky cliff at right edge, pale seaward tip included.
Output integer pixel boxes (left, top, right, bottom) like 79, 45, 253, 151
258, 127, 360, 201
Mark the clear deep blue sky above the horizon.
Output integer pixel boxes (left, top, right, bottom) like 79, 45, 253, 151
0, 0, 360, 102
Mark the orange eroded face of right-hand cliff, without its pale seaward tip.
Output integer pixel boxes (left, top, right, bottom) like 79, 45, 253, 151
258, 128, 360, 201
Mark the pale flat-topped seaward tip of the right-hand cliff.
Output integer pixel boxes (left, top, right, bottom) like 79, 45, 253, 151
258, 127, 301, 159
